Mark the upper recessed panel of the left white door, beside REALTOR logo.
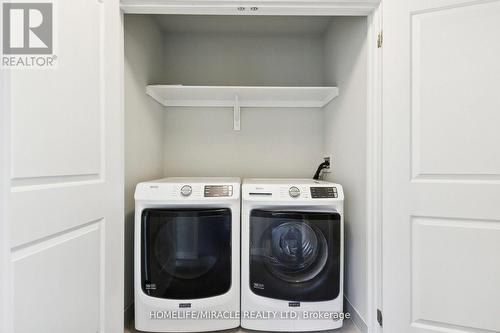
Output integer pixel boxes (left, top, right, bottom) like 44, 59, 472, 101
11, 0, 105, 179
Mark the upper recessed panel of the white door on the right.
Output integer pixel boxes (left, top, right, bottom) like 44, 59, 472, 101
410, 2, 500, 180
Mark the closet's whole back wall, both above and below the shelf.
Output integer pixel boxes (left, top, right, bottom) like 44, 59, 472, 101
160, 33, 323, 178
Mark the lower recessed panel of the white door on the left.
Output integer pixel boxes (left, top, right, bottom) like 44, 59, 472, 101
12, 220, 101, 333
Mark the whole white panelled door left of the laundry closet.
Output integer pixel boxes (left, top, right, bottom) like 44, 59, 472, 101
2, 0, 123, 333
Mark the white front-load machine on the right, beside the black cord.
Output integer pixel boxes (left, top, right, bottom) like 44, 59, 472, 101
241, 179, 344, 331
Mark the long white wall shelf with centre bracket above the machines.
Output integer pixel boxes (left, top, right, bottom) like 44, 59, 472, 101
146, 85, 339, 130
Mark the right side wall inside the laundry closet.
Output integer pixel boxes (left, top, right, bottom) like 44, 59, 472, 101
324, 17, 368, 323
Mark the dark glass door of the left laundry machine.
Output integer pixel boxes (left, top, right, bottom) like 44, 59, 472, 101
141, 208, 231, 299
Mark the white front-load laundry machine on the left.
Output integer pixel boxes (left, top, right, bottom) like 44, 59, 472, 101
134, 178, 240, 332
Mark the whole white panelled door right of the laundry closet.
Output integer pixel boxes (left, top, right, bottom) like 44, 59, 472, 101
383, 0, 500, 333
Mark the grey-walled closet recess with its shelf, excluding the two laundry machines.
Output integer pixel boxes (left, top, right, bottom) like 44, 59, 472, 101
124, 8, 376, 330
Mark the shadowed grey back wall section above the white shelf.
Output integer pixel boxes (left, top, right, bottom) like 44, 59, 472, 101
161, 33, 323, 86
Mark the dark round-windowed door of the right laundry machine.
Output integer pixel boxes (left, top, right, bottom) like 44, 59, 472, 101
250, 209, 341, 302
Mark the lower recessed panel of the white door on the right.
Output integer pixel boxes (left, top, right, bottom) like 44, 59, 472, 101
410, 216, 500, 331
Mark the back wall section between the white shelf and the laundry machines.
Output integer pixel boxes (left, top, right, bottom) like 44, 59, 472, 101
164, 108, 323, 178
